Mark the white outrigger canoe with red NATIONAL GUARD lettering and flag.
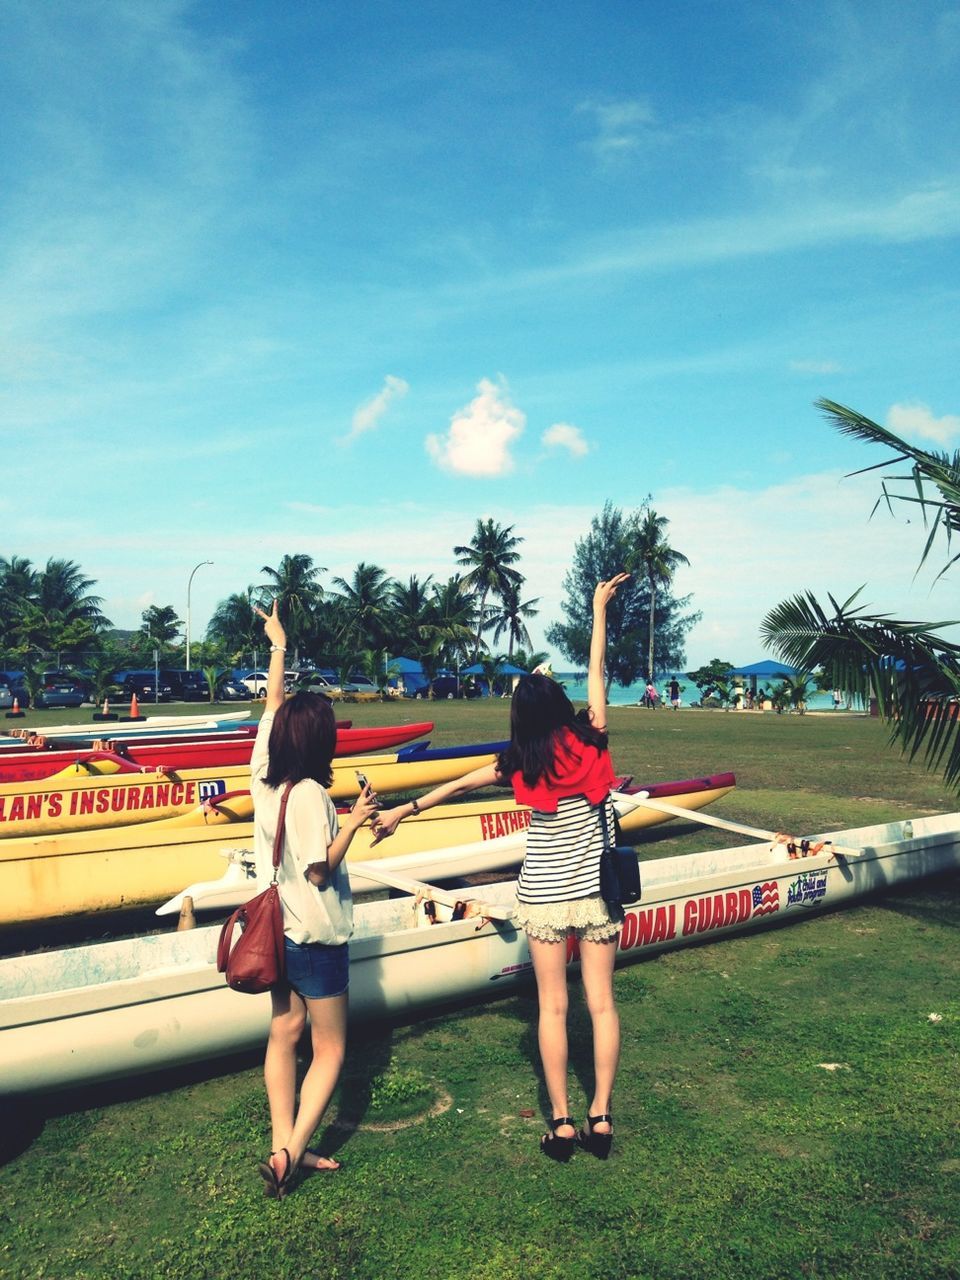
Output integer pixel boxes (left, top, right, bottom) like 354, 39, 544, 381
0, 813, 960, 1094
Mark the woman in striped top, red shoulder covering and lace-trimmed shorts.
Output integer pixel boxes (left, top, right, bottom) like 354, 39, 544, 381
375, 573, 630, 1161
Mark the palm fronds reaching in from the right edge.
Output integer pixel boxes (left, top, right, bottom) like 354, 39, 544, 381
762, 399, 960, 785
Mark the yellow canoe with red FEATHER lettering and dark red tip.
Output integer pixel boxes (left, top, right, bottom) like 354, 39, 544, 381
0, 773, 736, 925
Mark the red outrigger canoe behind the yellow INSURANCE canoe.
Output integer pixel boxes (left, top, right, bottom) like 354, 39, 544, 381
0, 721, 433, 785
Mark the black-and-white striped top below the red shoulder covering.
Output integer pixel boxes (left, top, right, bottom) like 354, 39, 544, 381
517, 795, 614, 902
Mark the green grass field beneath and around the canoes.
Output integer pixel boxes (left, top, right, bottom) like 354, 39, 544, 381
0, 703, 960, 1280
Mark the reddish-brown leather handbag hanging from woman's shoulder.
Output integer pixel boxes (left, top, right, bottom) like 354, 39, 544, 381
216, 782, 293, 996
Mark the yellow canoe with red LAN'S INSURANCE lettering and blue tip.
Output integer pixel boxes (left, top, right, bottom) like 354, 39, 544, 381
0, 742, 506, 846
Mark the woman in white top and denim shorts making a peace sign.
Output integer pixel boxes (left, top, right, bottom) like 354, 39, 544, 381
251, 600, 376, 1198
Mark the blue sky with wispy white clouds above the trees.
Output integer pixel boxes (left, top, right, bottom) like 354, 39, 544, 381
0, 0, 960, 667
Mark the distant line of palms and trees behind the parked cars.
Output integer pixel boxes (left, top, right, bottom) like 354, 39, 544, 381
0, 499, 700, 701
